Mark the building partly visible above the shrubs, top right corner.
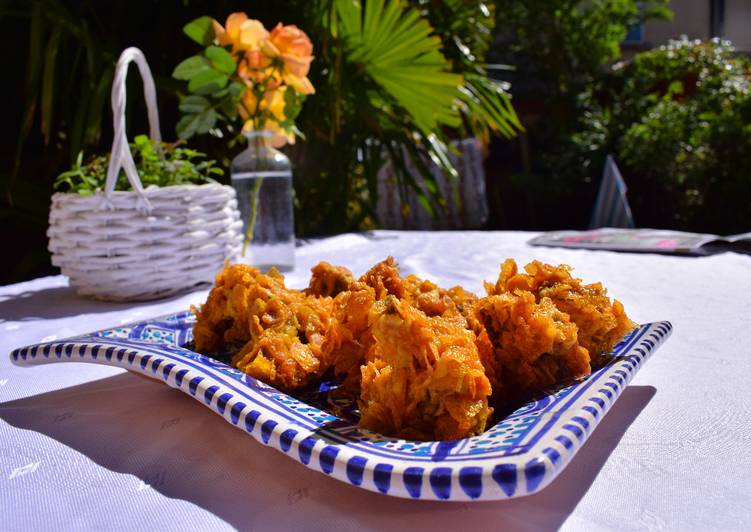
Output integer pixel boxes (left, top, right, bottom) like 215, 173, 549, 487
625, 0, 751, 53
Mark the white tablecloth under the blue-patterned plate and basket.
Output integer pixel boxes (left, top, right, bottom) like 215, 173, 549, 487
0, 231, 751, 531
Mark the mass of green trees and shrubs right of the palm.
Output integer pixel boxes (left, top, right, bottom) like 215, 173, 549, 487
489, 0, 751, 234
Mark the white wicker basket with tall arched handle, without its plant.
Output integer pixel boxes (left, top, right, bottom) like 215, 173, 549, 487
47, 48, 242, 301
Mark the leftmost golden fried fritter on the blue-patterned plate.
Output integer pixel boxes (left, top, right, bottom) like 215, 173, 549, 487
193, 264, 333, 391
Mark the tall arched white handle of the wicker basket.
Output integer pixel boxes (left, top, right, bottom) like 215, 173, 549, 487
104, 47, 162, 201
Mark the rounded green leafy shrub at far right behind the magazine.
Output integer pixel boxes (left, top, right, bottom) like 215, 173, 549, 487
579, 39, 751, 233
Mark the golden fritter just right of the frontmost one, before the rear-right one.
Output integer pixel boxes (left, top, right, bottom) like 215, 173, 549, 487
476, 290, 591, 401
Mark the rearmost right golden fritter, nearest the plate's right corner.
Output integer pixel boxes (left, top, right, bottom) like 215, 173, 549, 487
486, 259, 636, 358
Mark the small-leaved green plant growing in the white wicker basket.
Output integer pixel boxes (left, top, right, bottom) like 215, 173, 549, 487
55, 135, 224, 196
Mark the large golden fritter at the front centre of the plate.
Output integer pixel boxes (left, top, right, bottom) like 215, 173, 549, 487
360, 296, 492, 440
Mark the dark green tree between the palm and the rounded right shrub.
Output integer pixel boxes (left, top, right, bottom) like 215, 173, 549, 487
489, 0, 671, 229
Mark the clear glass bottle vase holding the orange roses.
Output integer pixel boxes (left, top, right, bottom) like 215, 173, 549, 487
230, 131, 295, 271
